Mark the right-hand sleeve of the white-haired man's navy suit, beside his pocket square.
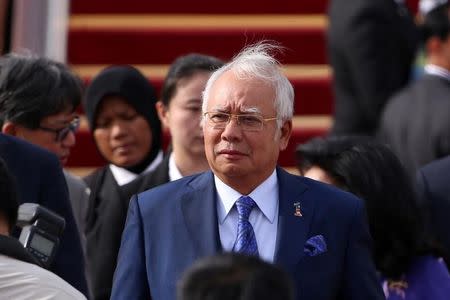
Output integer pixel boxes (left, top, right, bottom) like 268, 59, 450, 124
342, 200, 385, 300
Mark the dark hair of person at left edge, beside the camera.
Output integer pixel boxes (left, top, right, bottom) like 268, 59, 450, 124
0, 158, 19, 231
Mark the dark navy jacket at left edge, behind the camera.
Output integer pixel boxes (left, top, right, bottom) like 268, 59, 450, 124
0, 134, 88, 295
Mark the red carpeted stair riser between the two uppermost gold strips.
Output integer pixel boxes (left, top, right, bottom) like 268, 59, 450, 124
67, 28, 327, 64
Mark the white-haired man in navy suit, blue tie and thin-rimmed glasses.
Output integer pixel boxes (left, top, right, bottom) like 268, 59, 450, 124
112, 43, 384, 300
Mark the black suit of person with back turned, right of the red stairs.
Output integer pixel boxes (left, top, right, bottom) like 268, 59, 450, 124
328, 0, 418, 135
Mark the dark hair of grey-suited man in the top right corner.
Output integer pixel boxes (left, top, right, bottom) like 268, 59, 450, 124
421, 3, 450, 43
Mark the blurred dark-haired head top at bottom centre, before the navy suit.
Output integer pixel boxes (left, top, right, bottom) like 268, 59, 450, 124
177, 253, 294, 300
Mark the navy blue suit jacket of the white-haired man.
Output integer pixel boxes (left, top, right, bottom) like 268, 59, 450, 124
111, 168, 384, 300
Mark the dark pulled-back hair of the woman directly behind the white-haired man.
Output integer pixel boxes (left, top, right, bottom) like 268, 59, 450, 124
161, 53, 224, 106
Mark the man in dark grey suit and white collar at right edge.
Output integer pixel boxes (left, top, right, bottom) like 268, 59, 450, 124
378, 4, 450, 177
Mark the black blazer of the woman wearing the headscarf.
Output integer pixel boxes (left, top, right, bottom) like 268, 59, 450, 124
84, 156, 169, 300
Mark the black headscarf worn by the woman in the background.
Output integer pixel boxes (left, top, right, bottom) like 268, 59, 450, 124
83, 66, 161, 174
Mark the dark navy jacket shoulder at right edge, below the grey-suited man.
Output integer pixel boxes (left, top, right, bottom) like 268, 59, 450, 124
417, 156, 450, 262
